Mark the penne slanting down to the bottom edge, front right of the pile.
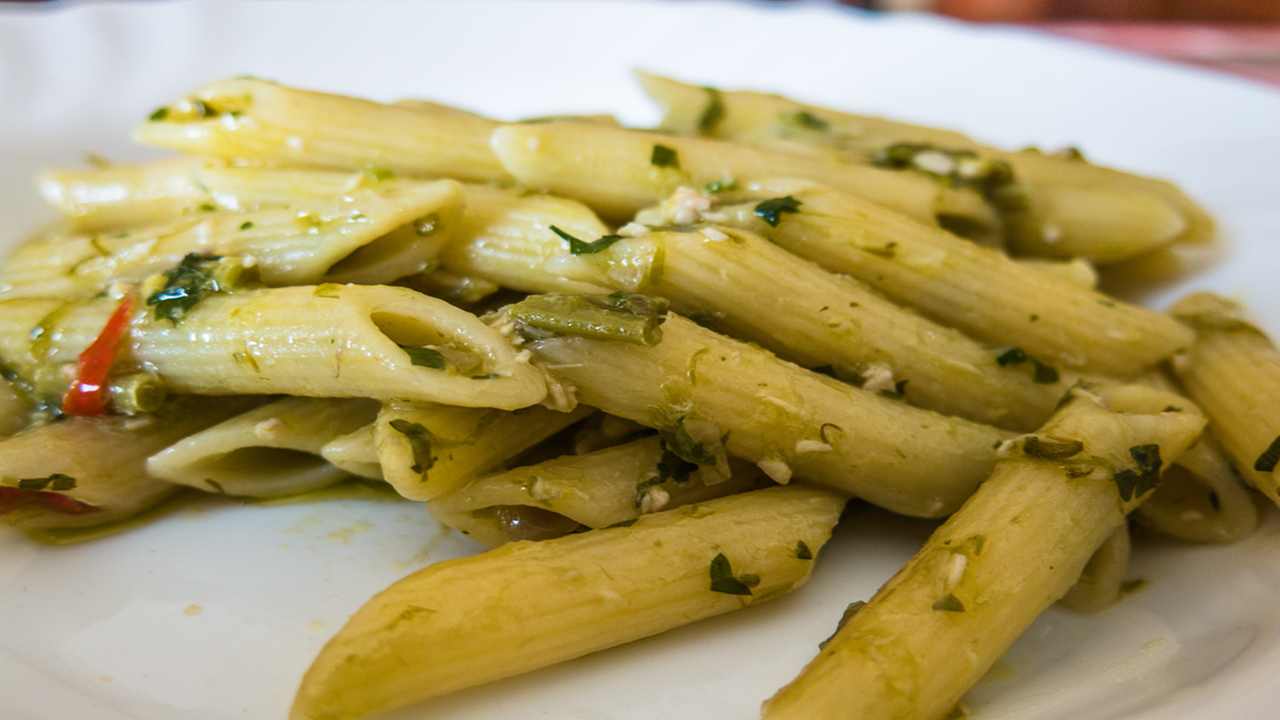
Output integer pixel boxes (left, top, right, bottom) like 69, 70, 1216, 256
764, 386, 1204, 720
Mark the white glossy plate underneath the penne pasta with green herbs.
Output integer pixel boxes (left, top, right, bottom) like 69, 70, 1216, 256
0, 1, 1280, 720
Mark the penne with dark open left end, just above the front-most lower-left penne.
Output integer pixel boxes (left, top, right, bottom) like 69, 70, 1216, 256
428, 437, 768, 547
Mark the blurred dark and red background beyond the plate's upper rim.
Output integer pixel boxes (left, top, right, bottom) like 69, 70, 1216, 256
0, 0, 1280, 87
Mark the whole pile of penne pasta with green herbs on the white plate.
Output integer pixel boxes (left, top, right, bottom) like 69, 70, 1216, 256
0, 74, 1280, 720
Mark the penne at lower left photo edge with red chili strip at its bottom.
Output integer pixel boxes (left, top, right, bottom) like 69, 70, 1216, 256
0, 398, 251, 530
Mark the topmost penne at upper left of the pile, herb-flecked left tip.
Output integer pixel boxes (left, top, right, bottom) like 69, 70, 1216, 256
133, 78, 508, 181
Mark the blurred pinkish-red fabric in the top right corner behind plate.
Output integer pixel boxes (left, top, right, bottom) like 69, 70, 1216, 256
1032, 22, 1280, 87
